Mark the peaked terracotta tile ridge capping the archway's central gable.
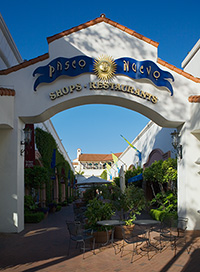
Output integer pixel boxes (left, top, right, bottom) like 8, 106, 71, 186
47, 14, 159, 47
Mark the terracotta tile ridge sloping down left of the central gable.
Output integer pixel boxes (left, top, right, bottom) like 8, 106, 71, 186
0, 53, 49, 75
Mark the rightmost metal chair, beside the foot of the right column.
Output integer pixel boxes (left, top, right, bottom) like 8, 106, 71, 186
160, 217, 189, 256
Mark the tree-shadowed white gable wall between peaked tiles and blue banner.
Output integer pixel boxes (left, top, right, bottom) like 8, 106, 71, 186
49, 22, 157, 61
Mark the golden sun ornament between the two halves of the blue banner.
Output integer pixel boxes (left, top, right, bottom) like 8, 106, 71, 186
93, 56, 117, 81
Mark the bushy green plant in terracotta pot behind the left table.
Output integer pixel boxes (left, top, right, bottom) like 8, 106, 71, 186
85, 198, 114, 243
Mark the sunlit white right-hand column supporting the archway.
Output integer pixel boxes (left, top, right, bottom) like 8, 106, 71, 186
178, 122, 200, 230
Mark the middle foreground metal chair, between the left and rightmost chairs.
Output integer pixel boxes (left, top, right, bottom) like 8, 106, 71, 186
121, 225, 149, 263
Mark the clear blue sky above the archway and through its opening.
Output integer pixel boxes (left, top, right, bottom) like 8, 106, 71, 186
0, 0, 200, 160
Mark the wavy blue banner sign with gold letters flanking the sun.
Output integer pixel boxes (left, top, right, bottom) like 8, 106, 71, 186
33, 55, 174, 95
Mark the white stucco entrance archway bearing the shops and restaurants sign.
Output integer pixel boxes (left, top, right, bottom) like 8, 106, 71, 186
0, 16, 200, 232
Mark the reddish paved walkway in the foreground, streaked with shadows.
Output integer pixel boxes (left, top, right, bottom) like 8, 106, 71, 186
0, 205, 200, 272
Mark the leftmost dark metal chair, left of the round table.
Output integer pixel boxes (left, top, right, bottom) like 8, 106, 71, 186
66, 221, 95, 259
